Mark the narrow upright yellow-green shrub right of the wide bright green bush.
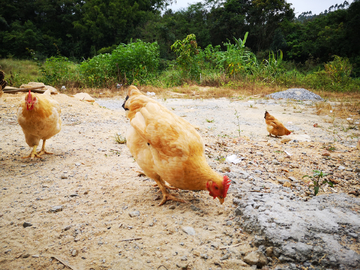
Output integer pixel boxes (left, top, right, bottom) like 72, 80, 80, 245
171, 34, 200, 80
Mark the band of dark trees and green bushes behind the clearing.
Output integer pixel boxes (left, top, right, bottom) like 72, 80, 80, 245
0, 0, 360, 91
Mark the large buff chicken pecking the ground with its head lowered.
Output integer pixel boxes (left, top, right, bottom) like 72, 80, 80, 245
123, 86, 230, 206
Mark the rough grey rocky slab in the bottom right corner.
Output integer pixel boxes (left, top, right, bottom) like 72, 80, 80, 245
234, 191, 360, 269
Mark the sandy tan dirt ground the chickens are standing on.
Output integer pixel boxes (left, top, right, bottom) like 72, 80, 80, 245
0, 91, 360, 270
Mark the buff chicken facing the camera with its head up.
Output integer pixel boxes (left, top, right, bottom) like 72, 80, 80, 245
17, 90, 61, 160
